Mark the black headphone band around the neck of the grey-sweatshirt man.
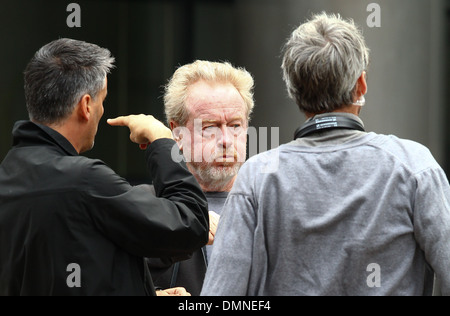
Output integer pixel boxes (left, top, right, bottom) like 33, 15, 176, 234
294, 115, 365, 139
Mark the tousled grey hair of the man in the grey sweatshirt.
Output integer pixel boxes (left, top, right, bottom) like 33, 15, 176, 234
281, 13, 369, 114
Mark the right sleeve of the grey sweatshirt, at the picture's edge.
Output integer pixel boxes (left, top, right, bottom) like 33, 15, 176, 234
414, 168, 450, 295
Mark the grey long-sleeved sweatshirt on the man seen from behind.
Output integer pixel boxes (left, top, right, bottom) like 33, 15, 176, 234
202, 116, 450, 296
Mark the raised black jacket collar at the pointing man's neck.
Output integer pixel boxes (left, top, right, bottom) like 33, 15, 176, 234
12, 121, 78, 156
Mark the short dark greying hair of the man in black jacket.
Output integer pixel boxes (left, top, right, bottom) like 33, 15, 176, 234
24, 38, 114, 124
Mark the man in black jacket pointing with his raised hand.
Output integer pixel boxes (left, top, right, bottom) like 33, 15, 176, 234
0, 39, 209, 295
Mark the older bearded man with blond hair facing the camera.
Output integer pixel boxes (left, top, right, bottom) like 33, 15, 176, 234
148, 60, 254, 296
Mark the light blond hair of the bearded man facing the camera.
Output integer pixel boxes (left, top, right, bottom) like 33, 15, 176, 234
164, 60, 254, 126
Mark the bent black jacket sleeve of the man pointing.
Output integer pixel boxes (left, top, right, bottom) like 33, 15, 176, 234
83, 139, 209, 258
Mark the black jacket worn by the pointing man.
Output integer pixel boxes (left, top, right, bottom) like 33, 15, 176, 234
0, 121, 209, 295
